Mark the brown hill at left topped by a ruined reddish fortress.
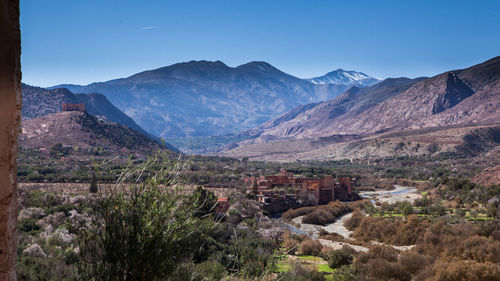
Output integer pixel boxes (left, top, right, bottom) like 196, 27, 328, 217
19, 111, 163, 157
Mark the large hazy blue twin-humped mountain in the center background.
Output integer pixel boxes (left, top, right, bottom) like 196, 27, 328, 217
51, 61, 372, 138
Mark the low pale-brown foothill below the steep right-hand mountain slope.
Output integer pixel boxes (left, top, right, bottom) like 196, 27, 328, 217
223, 125, 500, 162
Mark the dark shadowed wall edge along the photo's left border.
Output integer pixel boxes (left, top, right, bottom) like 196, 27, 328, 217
0, 0, 22, 281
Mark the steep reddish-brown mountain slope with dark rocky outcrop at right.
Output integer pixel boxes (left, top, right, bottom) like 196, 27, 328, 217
237, 57, 500, 142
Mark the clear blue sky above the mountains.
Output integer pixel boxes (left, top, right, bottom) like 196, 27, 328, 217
21, 0, 500, 86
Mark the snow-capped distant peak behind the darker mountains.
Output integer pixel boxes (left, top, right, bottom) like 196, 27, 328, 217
307, 68, 381, 87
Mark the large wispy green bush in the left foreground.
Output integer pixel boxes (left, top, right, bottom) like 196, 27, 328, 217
79, 155, 213, 280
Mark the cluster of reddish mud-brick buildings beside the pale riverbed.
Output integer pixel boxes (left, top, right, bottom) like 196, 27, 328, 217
245, 170, 359, 213
